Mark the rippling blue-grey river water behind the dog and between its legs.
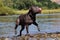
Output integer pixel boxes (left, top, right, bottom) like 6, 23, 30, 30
0, 14, 60, 37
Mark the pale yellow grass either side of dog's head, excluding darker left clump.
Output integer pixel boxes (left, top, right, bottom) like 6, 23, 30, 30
15, 9, 60, 14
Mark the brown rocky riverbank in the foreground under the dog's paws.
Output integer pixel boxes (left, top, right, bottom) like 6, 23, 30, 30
0, 33, 60, 40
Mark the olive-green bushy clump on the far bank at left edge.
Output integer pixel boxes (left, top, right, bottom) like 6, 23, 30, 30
0, 6, 15, 15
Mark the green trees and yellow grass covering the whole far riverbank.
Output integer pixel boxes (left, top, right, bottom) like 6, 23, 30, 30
0, 0, 60, 15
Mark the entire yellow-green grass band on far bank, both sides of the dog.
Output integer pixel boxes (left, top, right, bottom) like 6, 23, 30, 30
0, 6, 60, 15
